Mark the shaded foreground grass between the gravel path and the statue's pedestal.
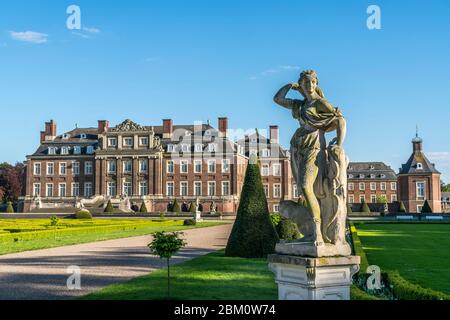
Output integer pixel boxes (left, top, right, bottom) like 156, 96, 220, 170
83, 251, 278, 300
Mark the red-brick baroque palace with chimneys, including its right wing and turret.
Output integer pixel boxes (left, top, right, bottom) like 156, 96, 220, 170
22, 118, 441, 213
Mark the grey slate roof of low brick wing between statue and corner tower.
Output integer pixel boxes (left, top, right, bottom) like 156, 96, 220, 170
347, 162, 397, 180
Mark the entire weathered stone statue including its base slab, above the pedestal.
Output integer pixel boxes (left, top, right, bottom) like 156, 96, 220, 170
274, 70, 351, 257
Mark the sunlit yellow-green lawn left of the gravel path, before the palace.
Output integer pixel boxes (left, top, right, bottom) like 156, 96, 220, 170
0, 219, 223, 255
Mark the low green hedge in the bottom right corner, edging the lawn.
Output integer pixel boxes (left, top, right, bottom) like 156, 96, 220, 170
386, 271, 450, 300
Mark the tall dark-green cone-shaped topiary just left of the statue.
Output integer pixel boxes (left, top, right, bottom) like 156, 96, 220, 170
225, 156, 279, 258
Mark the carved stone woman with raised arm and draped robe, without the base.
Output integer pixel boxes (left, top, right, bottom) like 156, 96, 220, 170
274, 70, 347, 246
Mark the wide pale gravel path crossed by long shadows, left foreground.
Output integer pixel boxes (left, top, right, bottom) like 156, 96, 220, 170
0, 224, 232, 300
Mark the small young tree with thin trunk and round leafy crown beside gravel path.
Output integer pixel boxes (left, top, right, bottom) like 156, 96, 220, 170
148, 231, 186, 299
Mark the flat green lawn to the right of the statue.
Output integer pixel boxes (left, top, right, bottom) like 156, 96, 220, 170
355, 223, 450, 294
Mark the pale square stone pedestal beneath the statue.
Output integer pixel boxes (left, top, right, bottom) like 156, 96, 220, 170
269, 254, 360, 300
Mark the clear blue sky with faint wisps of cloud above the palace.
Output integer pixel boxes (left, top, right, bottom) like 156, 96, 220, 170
0, 0, 450, 183
